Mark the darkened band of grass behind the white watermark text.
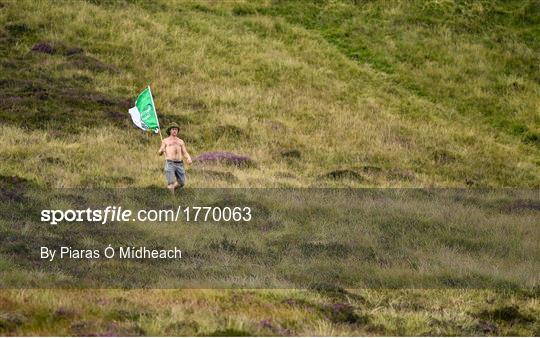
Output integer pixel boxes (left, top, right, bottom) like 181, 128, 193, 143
0, 186, 540, 290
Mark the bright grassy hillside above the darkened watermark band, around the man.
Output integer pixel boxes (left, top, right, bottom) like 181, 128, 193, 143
0, 1, 540, 187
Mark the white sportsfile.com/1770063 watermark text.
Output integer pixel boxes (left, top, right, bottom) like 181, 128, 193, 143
40, 206, 253, 225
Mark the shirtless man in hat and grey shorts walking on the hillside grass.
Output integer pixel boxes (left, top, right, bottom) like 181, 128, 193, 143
158, 122, 192, 191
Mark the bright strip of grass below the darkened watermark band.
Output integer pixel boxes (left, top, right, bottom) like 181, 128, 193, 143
0, 289, 540, 336
